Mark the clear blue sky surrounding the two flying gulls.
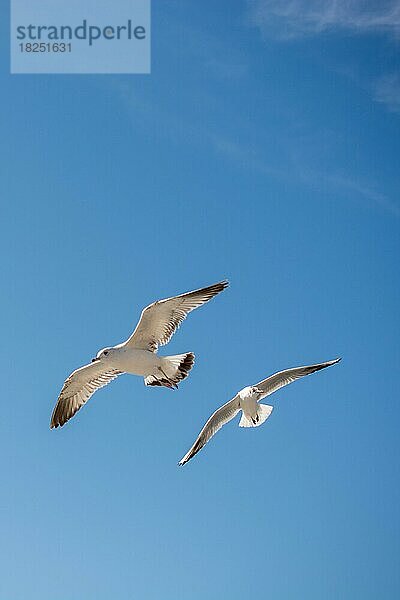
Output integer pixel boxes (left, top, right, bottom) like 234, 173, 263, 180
0, 0, 400, 600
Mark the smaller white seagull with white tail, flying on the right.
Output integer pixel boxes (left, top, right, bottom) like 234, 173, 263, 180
178, 358, 341, 465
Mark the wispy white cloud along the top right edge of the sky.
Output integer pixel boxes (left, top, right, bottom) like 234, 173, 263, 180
248, 0, 400, 39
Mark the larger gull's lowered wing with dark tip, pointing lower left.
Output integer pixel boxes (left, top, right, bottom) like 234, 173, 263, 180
50, 361, 122, 429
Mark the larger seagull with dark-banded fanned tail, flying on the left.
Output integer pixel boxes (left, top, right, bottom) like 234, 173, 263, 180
50, 281, 228, 429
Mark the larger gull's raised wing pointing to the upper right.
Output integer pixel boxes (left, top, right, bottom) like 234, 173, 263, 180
125, 281, 229, 352
